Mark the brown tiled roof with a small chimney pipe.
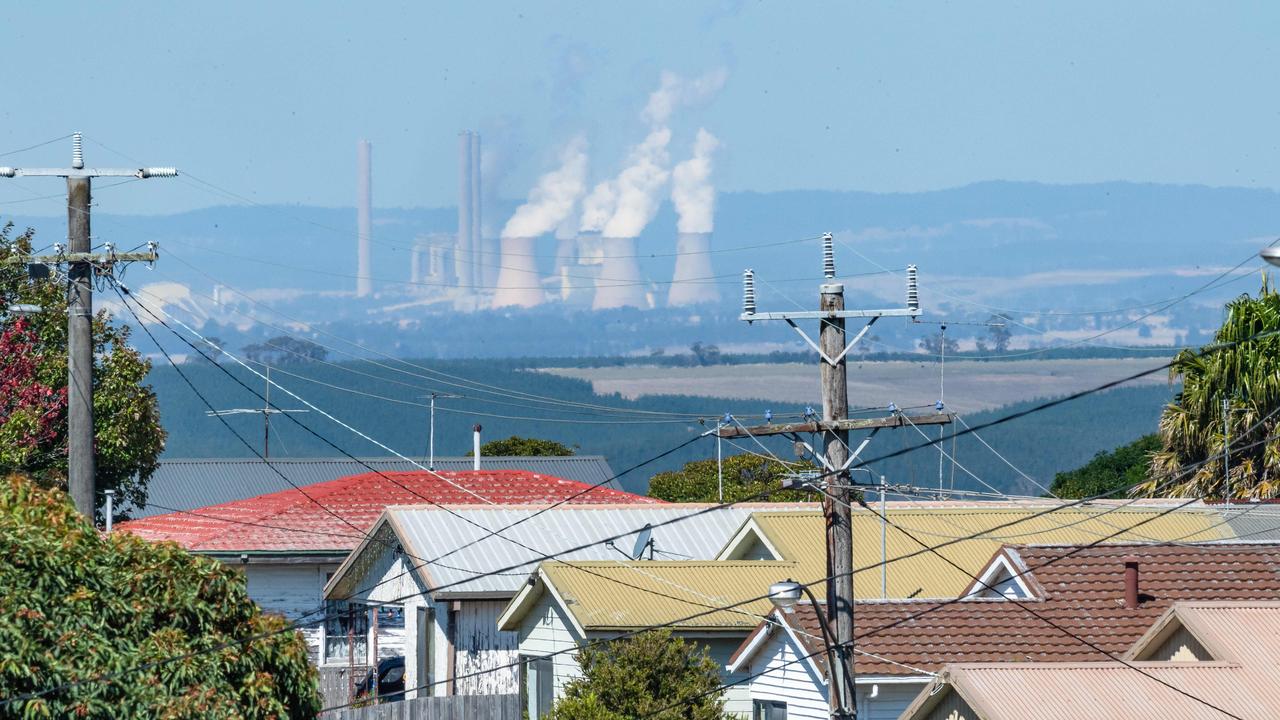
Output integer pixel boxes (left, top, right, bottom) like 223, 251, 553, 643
774, 543, 1280, 675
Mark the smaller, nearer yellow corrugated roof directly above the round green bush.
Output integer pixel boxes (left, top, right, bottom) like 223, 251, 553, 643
541, 560, 797, 630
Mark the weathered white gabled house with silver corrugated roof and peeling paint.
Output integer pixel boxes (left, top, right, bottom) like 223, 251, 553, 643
325, 503, 813, 698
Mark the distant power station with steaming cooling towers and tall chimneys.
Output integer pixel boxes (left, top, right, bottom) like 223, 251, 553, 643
356, 131, 721, 311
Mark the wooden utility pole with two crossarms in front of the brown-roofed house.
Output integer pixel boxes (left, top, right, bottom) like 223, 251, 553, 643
732, 233, 952, 720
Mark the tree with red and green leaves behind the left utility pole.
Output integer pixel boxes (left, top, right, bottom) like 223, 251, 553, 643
0, 223, 165, 515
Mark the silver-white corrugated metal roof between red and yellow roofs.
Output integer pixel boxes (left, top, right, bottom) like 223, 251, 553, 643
334, 502, 815, 596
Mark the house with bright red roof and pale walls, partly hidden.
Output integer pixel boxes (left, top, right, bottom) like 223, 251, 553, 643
116, 470, 660, 665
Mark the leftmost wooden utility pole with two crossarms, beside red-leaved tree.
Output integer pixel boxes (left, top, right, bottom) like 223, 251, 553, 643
0, 132, 178, 520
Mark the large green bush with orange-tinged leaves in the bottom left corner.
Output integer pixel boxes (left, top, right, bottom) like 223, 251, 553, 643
0, 475, 320, 719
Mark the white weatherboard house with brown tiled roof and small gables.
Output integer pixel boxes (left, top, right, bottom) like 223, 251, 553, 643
727, 542, 1280, 720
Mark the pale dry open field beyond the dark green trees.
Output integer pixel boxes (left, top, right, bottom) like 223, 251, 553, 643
544, 357, 1167, 413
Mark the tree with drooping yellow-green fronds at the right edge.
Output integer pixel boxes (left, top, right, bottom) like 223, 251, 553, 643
1138, 279, 1280, 498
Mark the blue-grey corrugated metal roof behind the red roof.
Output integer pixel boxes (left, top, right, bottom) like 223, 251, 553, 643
127, 455, 622, 519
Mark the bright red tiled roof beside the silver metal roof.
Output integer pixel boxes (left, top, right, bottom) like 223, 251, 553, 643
116, 470, 660, 552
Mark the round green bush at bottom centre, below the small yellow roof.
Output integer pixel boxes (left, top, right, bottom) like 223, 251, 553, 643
552, 629, 730, 720
